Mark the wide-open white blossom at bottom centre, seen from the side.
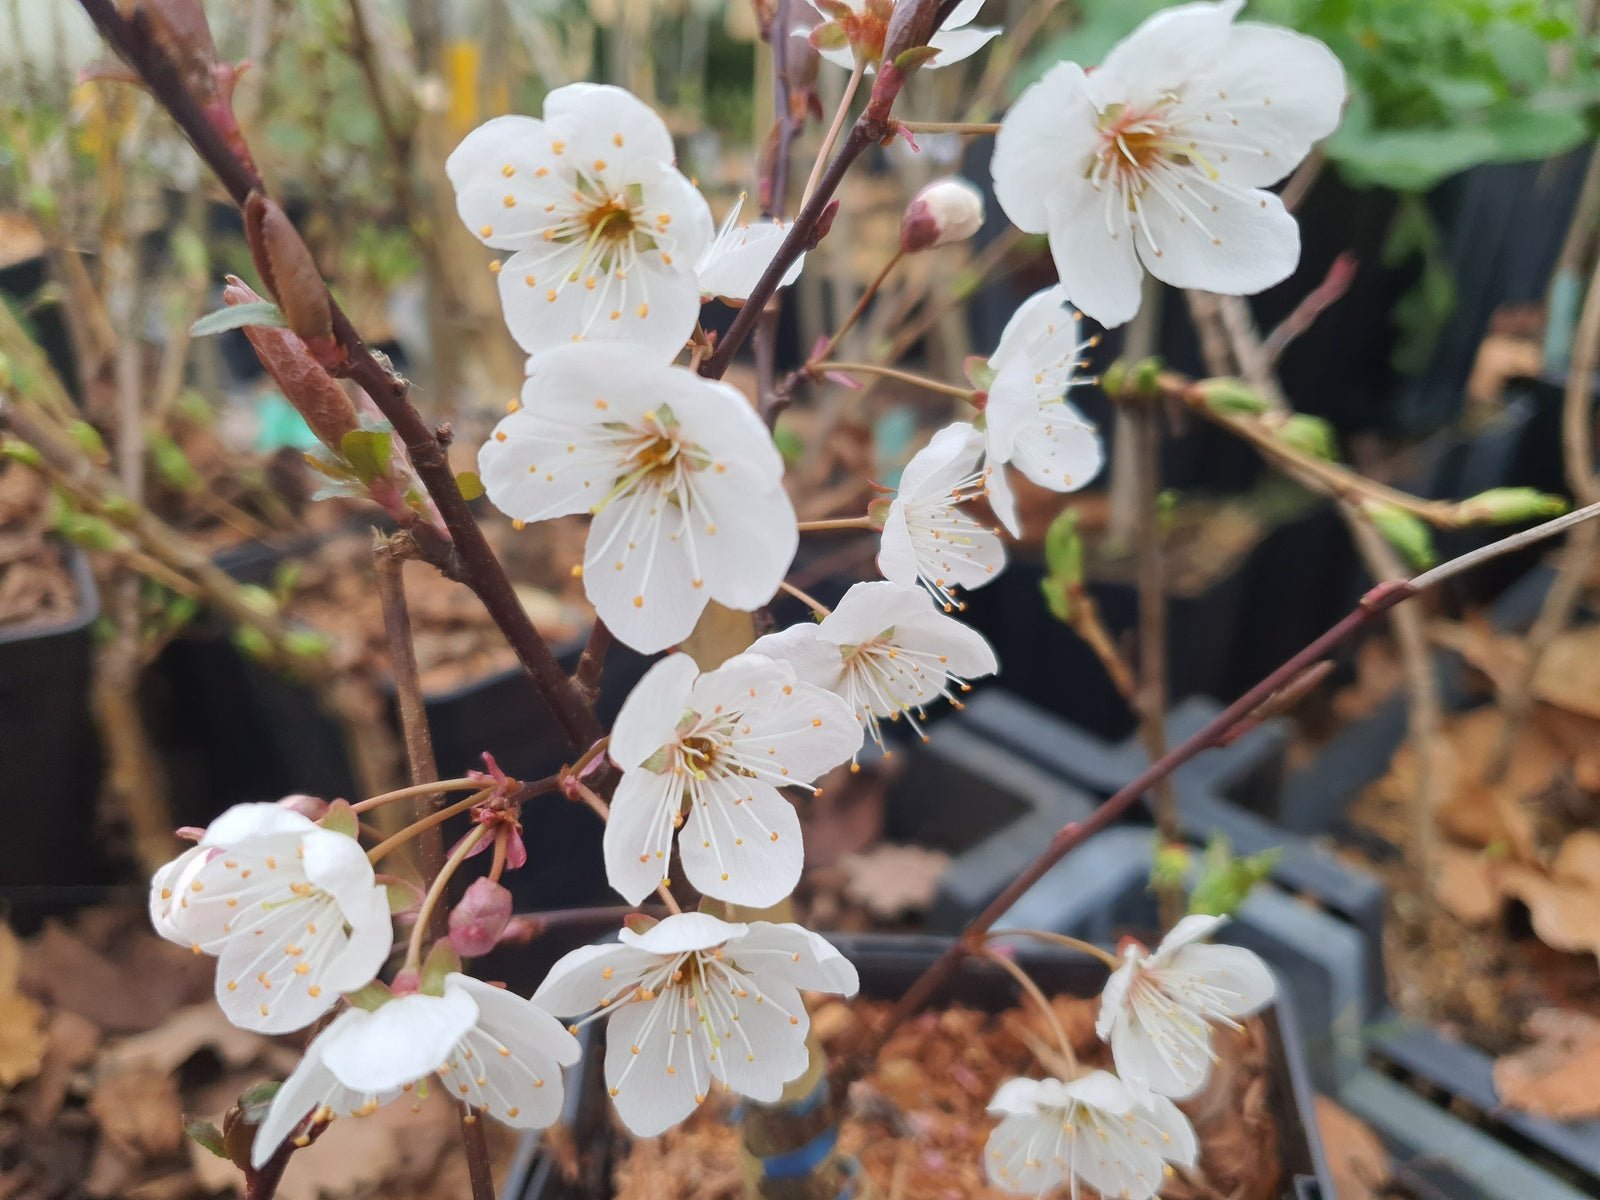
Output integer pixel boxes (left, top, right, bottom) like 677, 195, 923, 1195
533, 912, 858, 1138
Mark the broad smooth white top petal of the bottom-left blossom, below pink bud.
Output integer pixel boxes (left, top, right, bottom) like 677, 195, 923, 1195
323, 989, 478, 1091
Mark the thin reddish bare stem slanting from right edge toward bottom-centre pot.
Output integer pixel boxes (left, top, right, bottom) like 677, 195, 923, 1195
872, 504, 1600, 1053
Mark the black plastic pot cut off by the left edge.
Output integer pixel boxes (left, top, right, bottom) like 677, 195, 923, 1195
0, 550, 107, 926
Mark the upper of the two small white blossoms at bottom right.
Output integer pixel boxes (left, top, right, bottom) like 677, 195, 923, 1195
1094, 915, 1277, 1099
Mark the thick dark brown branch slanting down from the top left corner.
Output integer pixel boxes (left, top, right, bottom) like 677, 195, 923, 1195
80, 0, 601, 746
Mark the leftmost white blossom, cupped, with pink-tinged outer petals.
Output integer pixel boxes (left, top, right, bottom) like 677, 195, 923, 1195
150, 803, 394, 1034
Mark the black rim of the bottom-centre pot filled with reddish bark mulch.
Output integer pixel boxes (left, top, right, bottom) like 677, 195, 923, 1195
502, 934, 1334, 1200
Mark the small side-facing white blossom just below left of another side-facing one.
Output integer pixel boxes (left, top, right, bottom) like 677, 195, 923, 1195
878, 422, 1005, 613
